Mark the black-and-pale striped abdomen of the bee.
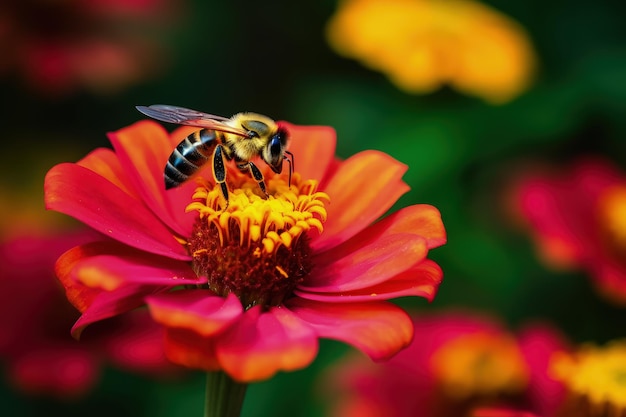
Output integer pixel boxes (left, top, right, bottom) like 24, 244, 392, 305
164, 129, 220, 190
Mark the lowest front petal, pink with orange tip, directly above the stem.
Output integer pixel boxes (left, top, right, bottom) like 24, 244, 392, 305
216, 307, 318, 382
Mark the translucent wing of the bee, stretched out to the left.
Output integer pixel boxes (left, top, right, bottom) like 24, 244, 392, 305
135, 104, 248, 136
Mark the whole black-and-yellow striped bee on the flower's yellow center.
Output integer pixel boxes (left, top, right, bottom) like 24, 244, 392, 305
136, 104, 293, 206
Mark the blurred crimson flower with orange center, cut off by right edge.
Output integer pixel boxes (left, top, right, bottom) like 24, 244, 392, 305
514, 158, 626, 304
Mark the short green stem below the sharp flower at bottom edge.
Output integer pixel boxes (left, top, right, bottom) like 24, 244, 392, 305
204, 371, 248, 417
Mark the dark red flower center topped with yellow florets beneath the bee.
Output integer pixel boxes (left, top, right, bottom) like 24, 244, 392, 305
187, 171, 329, 308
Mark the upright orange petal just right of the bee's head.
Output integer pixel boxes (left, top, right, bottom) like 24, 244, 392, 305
279, 121, 337, 182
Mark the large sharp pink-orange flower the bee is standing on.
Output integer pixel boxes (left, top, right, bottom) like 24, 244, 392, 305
45, 115, 446, 382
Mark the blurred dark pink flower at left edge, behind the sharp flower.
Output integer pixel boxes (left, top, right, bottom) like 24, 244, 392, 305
0, 231, 180, 398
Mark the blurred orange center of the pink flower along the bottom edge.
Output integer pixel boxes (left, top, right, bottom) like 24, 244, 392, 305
431, 333, 528, 401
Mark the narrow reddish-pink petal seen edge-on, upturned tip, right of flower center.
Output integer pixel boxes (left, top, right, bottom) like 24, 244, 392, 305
294, 259, 443, 303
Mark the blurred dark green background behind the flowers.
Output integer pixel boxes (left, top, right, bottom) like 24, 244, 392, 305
0, 0, 626, 417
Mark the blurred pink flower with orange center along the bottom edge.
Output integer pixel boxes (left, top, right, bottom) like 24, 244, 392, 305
321, 311, 565, 417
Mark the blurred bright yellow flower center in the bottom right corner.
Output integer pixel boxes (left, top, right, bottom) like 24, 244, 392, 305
549, 339, 626, 416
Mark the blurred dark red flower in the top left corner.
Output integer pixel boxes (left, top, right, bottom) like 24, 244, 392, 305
0, 0, 177, 94
